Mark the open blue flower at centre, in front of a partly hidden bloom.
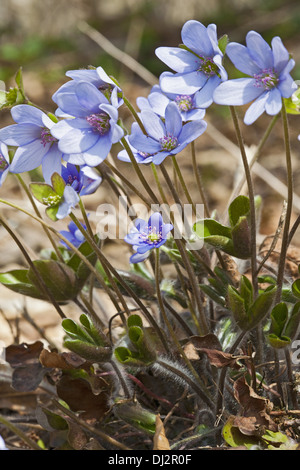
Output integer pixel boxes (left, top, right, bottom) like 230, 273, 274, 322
123, 102, 207, 165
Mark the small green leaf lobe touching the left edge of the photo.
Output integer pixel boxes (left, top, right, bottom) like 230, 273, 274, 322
0, 269, 43, 299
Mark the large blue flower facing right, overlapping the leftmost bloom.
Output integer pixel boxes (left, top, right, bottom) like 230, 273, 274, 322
51, 80, 124, 166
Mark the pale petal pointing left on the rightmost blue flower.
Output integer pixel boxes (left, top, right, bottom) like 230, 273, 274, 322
213, 78, 262, 106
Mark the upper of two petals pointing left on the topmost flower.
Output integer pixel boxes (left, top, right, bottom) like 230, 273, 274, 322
155, 47, 199, 73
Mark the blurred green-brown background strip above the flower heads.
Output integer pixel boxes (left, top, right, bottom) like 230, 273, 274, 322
0, 0, 300, 106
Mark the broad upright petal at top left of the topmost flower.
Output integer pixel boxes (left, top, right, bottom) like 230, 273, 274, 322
181, 20, 214, 57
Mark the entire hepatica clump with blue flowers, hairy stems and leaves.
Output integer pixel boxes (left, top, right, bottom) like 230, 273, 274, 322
0, 20, 300, 452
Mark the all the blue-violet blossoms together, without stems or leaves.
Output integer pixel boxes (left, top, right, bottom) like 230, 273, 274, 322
0, 20, 297, 262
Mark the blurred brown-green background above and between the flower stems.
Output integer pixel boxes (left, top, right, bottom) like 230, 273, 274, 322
0, 0, 300, 342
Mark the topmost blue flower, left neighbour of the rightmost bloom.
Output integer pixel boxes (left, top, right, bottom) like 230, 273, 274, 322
155, 20, 227, 108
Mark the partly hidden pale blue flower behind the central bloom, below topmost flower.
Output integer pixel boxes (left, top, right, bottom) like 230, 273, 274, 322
136, 72, 205, 122
